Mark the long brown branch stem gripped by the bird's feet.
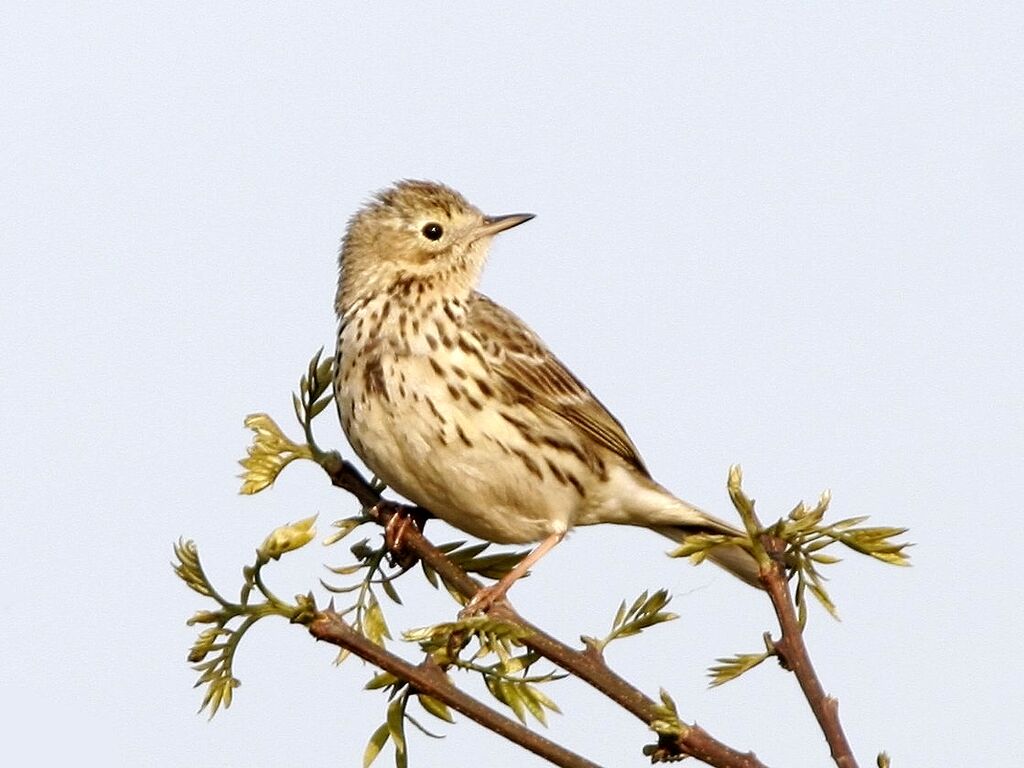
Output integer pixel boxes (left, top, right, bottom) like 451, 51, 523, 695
321, 452, 766, 768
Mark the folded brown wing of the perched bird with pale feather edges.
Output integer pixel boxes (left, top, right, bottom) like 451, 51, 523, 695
468, 294, 647, 475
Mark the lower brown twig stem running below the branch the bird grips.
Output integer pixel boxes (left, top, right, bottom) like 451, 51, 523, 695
309, 609, 599, 768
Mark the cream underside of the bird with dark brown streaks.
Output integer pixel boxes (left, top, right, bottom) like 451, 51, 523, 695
338, 355, 581, 544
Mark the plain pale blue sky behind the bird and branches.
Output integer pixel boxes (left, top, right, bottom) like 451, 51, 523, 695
0, 2, 1024, 768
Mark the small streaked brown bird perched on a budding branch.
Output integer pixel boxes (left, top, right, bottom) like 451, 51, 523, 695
334, 181, 759, 610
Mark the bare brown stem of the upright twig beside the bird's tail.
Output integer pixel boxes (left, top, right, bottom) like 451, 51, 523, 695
761, 535, 857, 768
